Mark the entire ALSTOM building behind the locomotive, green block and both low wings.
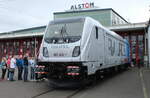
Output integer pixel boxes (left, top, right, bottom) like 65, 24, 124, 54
0, 8, 148, 64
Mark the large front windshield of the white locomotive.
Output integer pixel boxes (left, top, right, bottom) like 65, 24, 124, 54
44, 20, 84, 44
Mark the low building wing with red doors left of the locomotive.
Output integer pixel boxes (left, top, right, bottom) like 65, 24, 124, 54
0, 26, 46, 58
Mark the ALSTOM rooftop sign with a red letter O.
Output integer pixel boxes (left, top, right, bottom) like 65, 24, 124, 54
70, 2, 94, 10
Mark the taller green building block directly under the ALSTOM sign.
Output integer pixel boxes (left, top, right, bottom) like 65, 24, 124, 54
54, 8, 128, 26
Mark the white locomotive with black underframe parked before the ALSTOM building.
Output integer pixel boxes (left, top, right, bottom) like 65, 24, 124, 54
38, 17, 130, 86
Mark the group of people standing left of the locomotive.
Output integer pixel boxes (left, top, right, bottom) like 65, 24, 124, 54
0, 54, 36, 82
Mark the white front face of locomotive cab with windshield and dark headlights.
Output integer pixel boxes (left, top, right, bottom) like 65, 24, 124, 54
39, 18, 84, 62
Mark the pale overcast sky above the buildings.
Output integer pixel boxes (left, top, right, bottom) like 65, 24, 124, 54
0, 0, 150, 32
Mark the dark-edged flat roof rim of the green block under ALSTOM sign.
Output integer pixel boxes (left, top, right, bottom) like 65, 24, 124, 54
54, 8, 128, 23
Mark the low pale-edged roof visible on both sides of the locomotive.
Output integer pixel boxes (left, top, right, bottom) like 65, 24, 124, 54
0, 22, 148, 39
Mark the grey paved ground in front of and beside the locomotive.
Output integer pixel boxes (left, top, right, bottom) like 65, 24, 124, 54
0, 68, 150, 98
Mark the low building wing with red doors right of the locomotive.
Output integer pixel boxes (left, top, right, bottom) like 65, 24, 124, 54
108, 22, 148, 64
